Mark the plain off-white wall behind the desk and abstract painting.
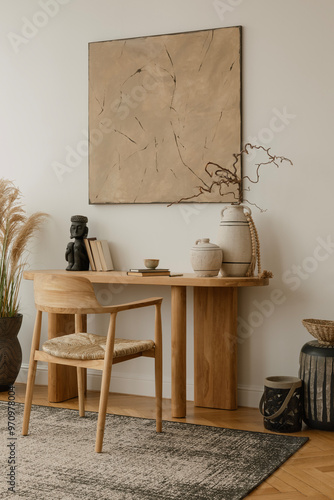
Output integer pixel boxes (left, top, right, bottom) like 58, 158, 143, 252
0, 0, 334, 406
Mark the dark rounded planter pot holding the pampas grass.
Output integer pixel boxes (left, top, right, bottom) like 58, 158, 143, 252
0, 314, 22, 392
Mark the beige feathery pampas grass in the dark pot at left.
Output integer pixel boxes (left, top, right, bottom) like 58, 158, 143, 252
0, 179, 47, 317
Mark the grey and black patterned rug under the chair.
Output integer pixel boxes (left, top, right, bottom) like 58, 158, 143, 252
0, 402, 308, 500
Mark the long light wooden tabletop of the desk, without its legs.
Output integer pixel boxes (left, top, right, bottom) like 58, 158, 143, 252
23, 269, 269, 288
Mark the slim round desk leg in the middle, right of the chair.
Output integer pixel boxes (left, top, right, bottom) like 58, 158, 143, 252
171, 286, 187, 418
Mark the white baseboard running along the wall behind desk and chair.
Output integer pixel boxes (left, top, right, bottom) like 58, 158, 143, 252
16, 364, 263, 408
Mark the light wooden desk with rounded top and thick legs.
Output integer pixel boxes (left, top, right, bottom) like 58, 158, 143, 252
24, 270, 269, 417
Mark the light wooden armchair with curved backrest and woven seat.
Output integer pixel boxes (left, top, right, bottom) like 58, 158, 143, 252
22, 274, 162, 453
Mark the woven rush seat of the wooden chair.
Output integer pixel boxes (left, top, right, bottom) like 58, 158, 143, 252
42, 333, 155, 359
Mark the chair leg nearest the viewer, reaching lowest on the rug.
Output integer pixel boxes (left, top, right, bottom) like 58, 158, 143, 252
95, 313, 116, 453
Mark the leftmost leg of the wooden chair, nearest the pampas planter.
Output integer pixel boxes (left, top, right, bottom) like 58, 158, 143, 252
22, 311, 42, 436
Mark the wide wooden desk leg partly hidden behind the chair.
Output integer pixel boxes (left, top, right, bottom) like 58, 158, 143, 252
48, 313, 86, 403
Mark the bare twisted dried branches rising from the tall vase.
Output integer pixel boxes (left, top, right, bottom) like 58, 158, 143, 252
168, 143, 293, 211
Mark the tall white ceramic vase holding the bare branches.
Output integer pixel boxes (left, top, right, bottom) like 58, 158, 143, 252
217, 205, 252, 277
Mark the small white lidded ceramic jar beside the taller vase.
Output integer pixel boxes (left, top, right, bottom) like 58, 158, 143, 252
190, 238, 223, 277
